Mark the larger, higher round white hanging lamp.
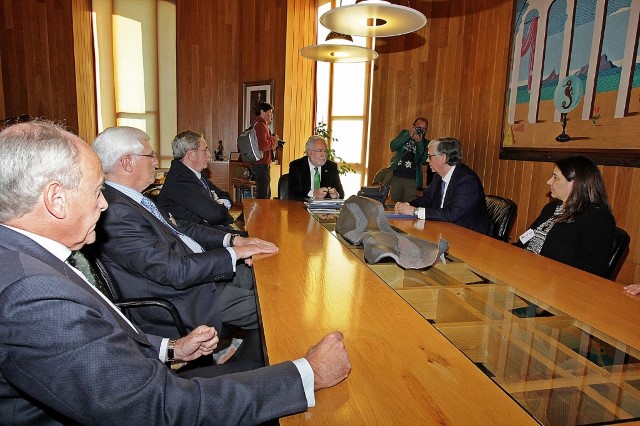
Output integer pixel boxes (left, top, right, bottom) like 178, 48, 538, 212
320, 0, 427, 37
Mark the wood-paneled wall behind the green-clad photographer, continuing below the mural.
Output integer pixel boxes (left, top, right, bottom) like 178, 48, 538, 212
369, 0, 640, 283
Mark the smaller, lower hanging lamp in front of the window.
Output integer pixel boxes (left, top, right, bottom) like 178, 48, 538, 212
300, 31, 378, 62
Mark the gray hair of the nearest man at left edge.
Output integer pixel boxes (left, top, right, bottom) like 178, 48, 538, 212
0, 120, 82, 223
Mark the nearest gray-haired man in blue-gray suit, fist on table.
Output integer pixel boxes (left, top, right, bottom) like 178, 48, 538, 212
0, 122, 350, 425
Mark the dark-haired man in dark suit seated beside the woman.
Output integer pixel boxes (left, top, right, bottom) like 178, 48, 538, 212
395, 137, 491, 234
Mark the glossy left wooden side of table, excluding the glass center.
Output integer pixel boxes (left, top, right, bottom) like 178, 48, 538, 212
243, 199, 540, 425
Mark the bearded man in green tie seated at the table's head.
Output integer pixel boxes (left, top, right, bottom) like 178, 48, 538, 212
289, 135, 344, 200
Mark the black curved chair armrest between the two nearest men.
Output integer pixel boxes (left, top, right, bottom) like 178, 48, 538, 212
82, 246, 188, 336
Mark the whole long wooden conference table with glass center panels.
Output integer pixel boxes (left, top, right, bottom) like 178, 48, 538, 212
243, 199, 640, 425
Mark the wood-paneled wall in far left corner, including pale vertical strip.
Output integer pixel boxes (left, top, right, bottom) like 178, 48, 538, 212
0, 0, 96, 138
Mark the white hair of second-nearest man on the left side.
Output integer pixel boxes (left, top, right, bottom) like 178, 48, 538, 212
92, 126, 149, 173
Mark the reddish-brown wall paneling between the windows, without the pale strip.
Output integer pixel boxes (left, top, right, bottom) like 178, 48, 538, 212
176, 0, 287, 163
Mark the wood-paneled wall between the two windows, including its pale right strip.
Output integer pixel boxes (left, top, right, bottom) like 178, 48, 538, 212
177, 0, 316, 173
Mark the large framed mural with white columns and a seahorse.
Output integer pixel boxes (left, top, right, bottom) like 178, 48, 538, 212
500, 0, 640, 166
